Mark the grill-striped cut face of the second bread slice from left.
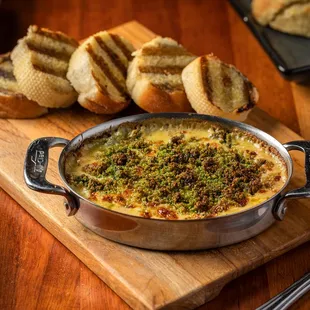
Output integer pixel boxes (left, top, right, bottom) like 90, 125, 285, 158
25, 26, 78, 80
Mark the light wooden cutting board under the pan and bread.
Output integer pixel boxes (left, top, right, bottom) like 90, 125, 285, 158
0, 22, 310, 309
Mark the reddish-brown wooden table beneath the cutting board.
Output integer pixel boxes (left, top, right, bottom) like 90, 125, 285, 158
0, 0, 310, 309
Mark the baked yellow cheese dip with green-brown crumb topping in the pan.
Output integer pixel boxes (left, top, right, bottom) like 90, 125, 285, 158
65, 119, 287, 220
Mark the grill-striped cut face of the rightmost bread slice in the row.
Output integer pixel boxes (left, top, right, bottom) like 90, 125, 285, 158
200, 55, 255, 113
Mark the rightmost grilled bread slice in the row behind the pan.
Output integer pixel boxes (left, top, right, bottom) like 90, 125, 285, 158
182, 55, 259, 121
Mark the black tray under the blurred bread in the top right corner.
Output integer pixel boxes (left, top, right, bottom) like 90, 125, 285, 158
230, 0, 310, 83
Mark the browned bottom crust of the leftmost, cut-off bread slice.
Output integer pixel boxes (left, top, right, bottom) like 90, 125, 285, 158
0, 92, 48, 119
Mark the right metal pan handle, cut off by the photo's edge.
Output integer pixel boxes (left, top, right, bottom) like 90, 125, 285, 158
273, 140, 310, 221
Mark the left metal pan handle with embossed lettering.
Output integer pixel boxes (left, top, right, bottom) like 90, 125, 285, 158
24, 137, 78, 216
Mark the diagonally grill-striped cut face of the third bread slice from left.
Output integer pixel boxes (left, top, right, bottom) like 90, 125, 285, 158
86, 31, 133, 102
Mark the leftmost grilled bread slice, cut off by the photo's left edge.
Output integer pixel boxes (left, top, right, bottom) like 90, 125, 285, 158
0, 53, 48, 118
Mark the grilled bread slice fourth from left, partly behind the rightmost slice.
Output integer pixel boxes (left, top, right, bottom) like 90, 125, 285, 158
127, 37, 195, 112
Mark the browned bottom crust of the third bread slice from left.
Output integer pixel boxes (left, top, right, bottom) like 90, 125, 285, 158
79, 92, 130, 114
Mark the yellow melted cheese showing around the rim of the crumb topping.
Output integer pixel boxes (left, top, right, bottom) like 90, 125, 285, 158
66, 121, 287, 219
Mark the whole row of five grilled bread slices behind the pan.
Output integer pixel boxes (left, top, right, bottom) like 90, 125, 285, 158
0, 24, 260, 121
